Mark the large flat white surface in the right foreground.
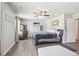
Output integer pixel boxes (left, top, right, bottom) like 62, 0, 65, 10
38, 45, 78, 56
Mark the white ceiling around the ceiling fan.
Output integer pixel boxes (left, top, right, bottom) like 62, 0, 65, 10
8, 2, 79, 18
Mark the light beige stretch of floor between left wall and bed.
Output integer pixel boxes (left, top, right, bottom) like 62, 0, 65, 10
9, 39, 38, 56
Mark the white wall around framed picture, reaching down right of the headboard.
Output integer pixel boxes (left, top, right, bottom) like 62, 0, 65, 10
46, 14, 66, 43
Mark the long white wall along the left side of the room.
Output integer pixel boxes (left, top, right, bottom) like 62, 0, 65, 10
1, 3, 16, 55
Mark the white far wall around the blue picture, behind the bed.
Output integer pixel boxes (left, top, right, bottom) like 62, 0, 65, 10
21, 19, 46, 37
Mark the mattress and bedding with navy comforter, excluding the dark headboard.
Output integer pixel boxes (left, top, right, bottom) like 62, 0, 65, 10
32, 31, 62, 44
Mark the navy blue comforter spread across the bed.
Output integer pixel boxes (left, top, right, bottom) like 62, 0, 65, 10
32, 31, 57, 42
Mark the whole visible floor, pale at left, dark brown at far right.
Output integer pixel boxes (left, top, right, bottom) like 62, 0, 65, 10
6, 38, 79, 56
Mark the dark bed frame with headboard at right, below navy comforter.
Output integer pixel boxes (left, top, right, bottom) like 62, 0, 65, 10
33, 29, 63, 45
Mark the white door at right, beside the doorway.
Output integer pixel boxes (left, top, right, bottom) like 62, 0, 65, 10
66, 18, 75, 43
